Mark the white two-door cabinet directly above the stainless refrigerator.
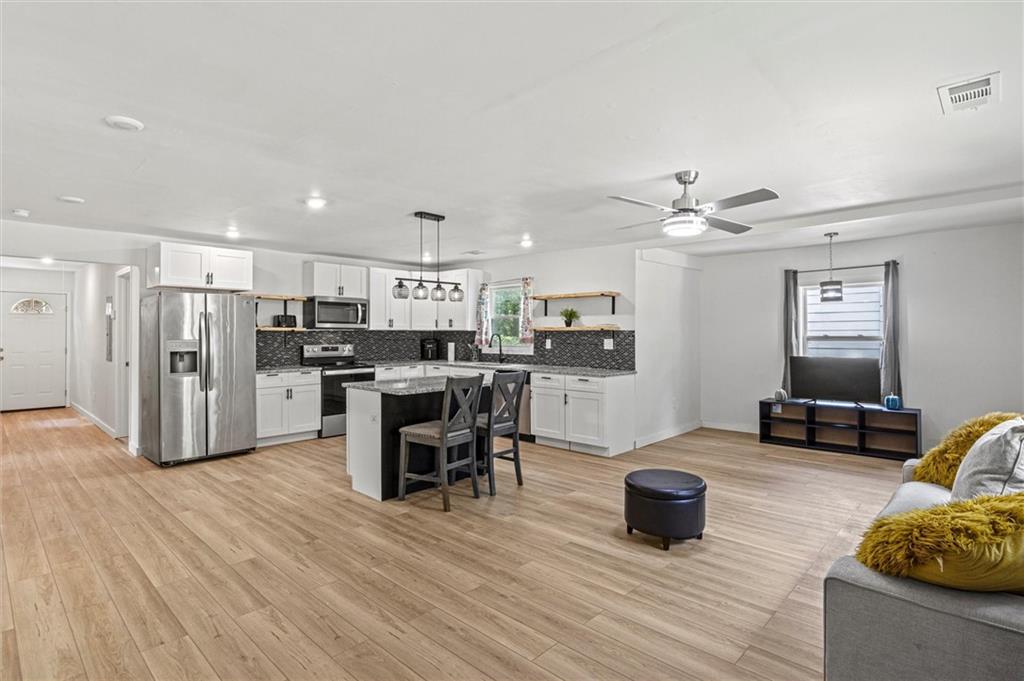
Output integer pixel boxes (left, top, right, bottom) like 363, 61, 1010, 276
146, 242, 253, 291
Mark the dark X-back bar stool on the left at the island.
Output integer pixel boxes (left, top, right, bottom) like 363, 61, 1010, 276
398, 374, 483, 511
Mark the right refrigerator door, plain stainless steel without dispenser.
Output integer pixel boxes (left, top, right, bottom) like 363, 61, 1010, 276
206, 294, 256, 455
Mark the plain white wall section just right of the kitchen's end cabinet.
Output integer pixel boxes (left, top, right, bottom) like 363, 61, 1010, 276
636, 249, 701, 446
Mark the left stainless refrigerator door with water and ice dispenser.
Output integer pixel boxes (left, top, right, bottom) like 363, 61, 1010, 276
159, 292, 207, 463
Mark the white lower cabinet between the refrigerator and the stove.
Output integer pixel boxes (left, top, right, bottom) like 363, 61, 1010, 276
256, 371, 321, 445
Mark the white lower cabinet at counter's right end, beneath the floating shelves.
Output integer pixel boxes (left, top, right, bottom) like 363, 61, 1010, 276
529, 373, 636, 457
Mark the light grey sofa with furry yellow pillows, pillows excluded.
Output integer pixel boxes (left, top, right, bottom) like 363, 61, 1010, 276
824, 459, 1024, 681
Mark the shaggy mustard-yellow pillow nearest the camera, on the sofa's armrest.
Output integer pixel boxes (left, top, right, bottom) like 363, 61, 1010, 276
857, 493, 1024, 593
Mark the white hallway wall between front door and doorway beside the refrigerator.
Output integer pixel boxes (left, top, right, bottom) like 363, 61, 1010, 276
71, 264, 121, 434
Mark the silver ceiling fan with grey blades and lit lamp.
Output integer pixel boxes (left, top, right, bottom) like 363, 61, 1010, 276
608, 170, 778, 237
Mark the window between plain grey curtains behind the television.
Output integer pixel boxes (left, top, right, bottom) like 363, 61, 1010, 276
801, 282, 885, 359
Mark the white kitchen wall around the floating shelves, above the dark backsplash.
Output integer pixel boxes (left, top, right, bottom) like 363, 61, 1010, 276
472, 246, 636, 329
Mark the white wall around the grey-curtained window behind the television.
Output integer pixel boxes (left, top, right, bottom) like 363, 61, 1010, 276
700, 224, 1024, 445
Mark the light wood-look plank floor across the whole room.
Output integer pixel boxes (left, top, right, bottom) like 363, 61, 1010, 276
0, 410, 899, 681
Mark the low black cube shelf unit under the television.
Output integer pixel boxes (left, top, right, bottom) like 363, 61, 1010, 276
759, 399, 921, 460
